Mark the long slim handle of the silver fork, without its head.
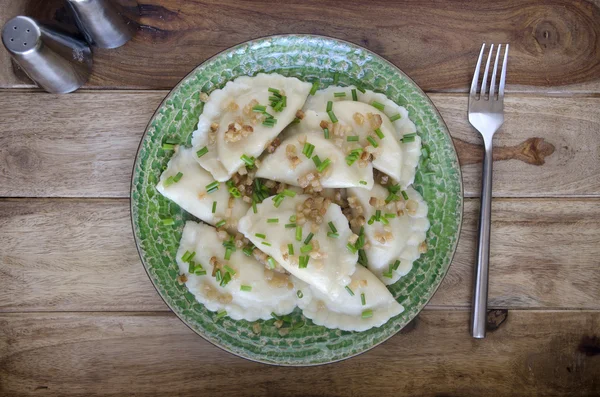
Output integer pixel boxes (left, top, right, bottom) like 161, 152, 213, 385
471, 139, 492, 338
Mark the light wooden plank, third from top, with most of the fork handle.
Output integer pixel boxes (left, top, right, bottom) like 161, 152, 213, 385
0, 199, 600, 312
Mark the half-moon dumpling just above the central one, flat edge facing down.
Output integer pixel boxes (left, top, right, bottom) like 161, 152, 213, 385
256, 132, 373, 189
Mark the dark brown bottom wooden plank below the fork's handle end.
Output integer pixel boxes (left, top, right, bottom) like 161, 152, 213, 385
0, 311, 600, 397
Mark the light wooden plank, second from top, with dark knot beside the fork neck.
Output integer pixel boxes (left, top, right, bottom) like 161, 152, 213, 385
0, 91, 600, 197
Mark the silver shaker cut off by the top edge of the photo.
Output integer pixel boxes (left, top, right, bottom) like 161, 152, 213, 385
67, 0, 137, 48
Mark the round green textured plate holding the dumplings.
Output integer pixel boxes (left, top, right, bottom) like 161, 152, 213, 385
131, 35, 462, 365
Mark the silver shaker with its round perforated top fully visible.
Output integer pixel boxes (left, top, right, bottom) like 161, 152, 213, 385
2, 16, 92, 94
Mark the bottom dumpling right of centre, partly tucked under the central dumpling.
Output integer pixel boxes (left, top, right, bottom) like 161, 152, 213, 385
298, 266, 404, 331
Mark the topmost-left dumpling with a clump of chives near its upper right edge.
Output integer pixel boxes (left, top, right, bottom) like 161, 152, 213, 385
192, 73, 311, 182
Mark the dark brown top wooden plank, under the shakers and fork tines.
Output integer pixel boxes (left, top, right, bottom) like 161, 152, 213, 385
0, 0, 600, 93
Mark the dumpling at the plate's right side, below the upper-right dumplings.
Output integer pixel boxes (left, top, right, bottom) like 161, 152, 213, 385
348, 183, 429, 284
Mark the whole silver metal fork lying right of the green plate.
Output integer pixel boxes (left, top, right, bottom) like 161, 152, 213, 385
469, 43, 508, 338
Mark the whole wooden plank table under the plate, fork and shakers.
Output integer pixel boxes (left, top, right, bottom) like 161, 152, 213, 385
0, 0, 600, 397
